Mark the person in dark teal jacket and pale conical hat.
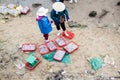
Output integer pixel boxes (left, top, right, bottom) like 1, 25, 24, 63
50, 2, 69, 36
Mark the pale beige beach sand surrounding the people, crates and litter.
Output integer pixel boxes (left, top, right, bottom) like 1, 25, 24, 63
0, 0, 120, 80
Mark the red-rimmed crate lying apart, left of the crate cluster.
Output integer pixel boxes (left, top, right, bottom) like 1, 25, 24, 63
21, 43, 36, 52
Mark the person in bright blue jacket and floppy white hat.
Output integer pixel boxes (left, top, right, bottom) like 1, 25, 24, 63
36, 7, 52, 42
